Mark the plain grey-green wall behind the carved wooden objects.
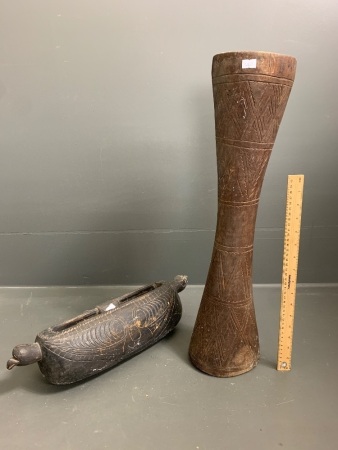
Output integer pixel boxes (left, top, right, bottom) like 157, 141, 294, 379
0, 0, 338, 285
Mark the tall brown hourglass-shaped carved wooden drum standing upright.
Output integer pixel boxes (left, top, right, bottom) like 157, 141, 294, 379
189, 52, 296, 377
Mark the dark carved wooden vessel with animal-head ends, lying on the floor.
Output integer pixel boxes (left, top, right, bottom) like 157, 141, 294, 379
7, 275, 187, 384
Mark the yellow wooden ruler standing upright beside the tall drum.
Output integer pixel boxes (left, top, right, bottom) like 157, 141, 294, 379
277, 175, 304, 371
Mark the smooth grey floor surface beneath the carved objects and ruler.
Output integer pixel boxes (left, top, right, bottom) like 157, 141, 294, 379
0, 285, 338, 450
